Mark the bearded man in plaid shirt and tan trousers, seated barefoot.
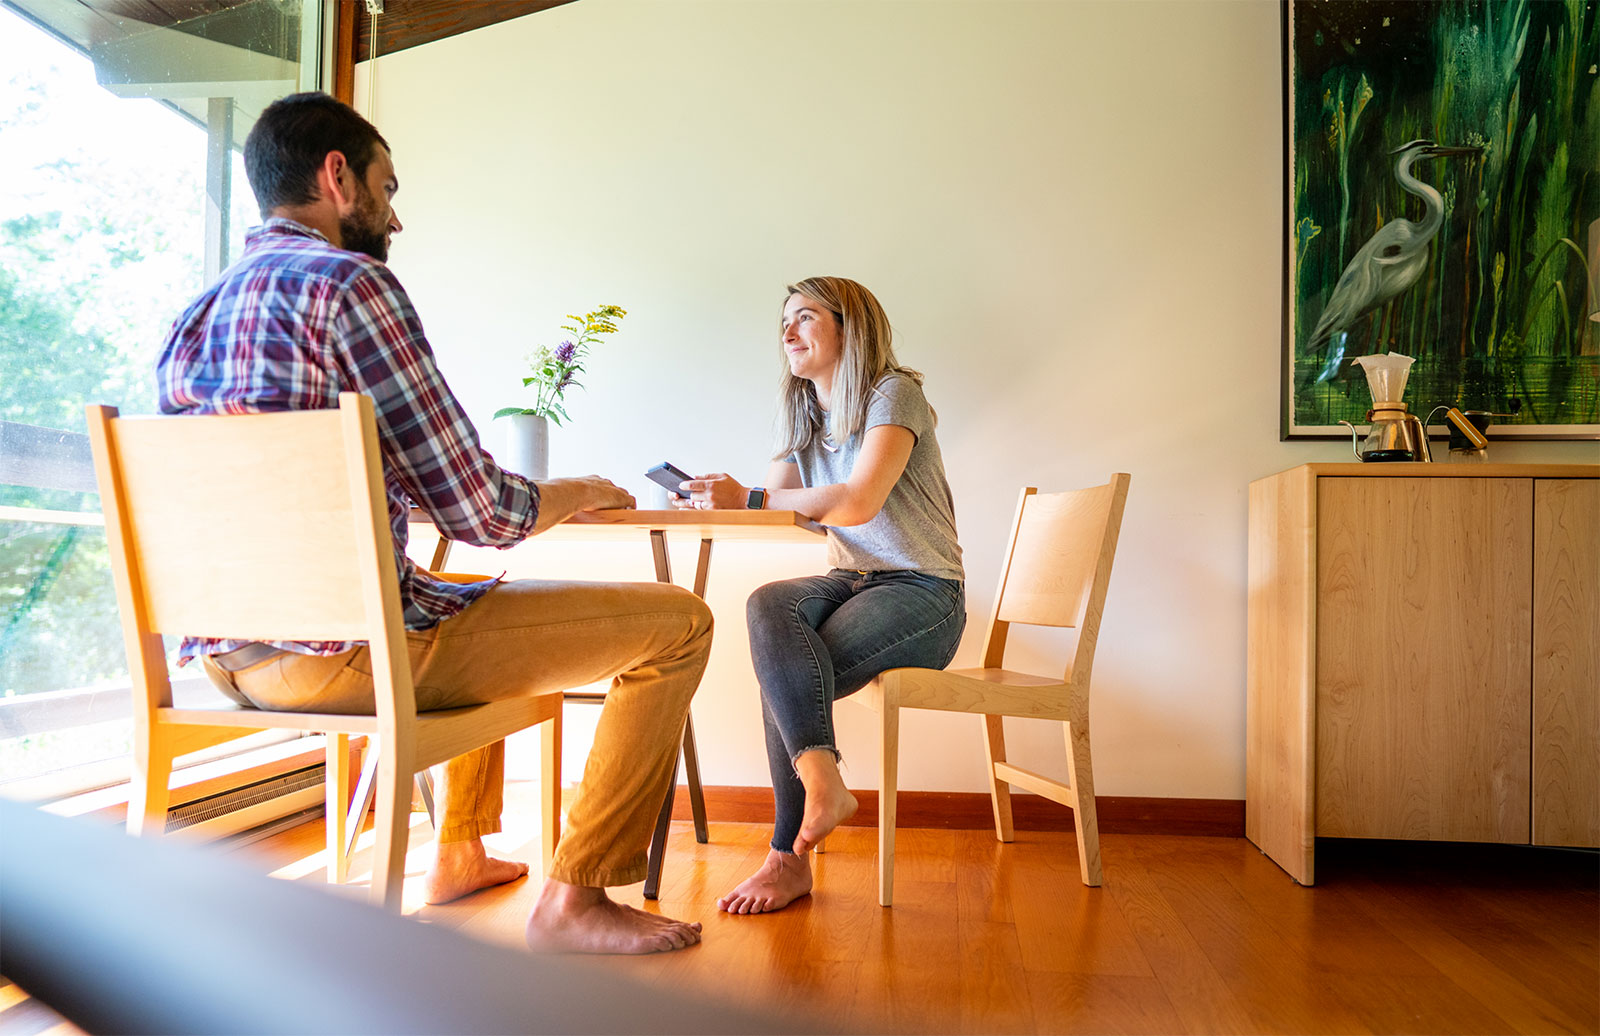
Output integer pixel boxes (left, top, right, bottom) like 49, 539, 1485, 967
157, 93, 712, 953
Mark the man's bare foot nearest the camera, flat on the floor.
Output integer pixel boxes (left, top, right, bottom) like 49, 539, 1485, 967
525, 878, 701, 953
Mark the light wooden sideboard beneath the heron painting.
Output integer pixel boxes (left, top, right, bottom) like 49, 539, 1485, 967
1245, 464, 1600, 884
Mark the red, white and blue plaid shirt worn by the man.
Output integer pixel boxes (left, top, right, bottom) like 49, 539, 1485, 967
155, 219, 539, 662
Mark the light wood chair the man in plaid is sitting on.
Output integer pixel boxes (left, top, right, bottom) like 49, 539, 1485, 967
88, 392, 562, 910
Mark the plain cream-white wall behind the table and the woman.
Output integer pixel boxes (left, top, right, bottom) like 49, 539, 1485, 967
357, 0, 1595, 798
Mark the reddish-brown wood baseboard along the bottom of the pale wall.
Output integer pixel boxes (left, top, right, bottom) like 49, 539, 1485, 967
672, 785, 1245, 838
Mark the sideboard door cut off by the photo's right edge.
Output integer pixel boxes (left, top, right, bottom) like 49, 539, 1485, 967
1533, 478, 1600, 846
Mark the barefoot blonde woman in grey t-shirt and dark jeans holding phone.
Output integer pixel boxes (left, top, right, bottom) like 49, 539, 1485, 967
678, 277, 966, 913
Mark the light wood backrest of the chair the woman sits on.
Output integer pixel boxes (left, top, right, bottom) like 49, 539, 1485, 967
984, 473, 1130, 683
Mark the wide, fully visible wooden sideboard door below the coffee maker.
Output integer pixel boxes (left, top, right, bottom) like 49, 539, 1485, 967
1317, 476, 1533, 843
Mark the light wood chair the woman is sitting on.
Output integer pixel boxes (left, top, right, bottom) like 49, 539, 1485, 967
848, 475, 1128, 907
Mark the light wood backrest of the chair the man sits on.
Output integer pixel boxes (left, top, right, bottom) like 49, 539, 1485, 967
88, 392, 411, 715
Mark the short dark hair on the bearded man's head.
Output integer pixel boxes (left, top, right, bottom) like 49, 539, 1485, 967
245, 93, 389, 217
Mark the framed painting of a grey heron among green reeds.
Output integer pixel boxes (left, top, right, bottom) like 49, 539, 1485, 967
1282, 0, 1600, 440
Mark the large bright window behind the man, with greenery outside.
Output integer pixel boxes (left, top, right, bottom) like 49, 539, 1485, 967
0, 0, 323, 782
